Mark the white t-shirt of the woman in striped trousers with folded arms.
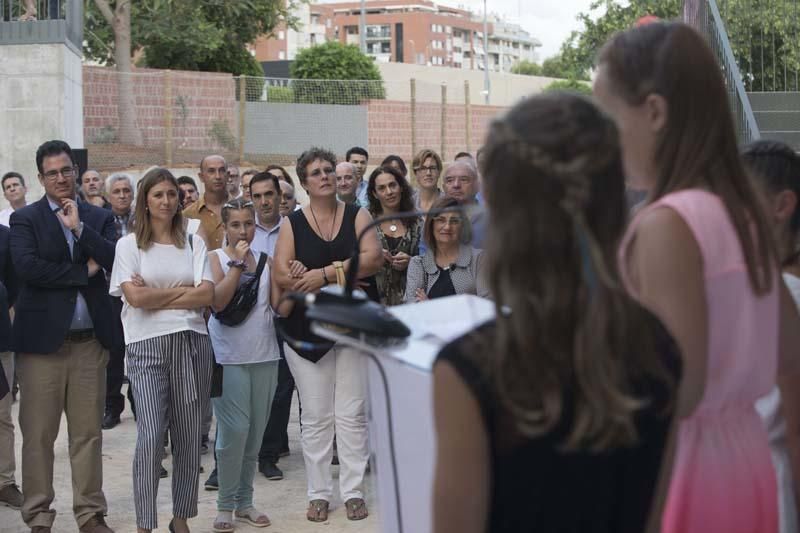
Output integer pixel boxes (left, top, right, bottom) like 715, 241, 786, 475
109, 233, 214, 345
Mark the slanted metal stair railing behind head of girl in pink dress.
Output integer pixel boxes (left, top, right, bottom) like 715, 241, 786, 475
684, 0, 761, 143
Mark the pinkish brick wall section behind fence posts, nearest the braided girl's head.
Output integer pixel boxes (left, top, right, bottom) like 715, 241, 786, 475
367, 100, 505, 165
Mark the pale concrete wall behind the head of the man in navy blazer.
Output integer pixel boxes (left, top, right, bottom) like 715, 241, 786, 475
0, 44, 84, 208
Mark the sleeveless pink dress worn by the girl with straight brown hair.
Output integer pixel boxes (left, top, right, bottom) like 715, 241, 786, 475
620, 189, 780, 533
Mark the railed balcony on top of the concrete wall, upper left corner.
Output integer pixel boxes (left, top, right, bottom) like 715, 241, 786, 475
0, 0, 83, 56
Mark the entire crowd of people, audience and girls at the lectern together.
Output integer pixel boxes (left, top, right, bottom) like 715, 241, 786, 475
0, 17, 800, 533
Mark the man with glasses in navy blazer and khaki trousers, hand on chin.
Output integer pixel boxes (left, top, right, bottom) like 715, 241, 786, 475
11, 141, 116, 533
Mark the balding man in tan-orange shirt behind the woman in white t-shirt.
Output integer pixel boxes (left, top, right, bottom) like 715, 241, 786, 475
183, 155, 228, 251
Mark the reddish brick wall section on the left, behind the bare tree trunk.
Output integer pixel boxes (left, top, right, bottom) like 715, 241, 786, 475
83, 66, 237, 168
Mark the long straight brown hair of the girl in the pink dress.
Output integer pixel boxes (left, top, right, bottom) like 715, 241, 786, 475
598, 22, 778, 294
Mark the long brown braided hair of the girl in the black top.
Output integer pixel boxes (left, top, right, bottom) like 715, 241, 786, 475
481, 93, 674, 451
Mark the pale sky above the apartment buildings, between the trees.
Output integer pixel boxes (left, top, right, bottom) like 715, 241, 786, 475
317, 0, 592, 61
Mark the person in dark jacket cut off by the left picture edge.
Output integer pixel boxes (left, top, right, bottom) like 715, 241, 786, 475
0, 225, 22, 509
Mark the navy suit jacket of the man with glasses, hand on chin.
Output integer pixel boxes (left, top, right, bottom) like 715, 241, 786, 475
10, 196, 117, 353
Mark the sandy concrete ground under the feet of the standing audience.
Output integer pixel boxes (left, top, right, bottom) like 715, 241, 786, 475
0, 392, 380, 533
